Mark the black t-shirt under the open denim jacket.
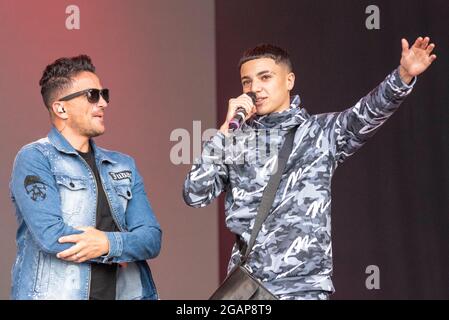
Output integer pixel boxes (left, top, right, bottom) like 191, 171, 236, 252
78, 147, 118, 300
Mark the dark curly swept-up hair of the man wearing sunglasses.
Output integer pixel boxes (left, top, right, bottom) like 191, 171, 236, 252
39, 54, 95, 109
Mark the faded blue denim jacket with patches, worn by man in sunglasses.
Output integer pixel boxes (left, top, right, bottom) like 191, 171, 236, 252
10, 128, 162, 299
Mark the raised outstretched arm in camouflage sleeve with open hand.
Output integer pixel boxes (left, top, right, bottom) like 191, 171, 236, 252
330, 37, 436, 162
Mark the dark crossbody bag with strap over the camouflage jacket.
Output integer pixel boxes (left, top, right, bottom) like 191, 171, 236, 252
209, 130, 296, 300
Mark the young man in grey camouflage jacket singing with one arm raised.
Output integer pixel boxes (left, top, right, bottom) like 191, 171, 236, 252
183, 37, 436, 299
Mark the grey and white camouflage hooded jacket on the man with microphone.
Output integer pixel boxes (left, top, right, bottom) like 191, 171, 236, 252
183, 69, 416, 299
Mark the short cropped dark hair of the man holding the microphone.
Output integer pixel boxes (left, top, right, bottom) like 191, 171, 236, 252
238, 43, 293, 71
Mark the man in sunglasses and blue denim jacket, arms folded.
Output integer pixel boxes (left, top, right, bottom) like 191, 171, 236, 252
10, 55, 161, 300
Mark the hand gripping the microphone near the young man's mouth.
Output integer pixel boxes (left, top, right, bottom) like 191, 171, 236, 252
220, 92, 256, 134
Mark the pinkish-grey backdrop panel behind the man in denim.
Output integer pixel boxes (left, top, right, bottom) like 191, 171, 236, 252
0, 0, 218, 299
